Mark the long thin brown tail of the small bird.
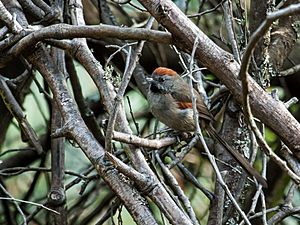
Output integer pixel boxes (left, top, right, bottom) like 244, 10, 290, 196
206, 124, 268, 188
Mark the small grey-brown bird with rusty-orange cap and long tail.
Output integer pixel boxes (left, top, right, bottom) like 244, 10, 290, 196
147, 67, 268, 188
